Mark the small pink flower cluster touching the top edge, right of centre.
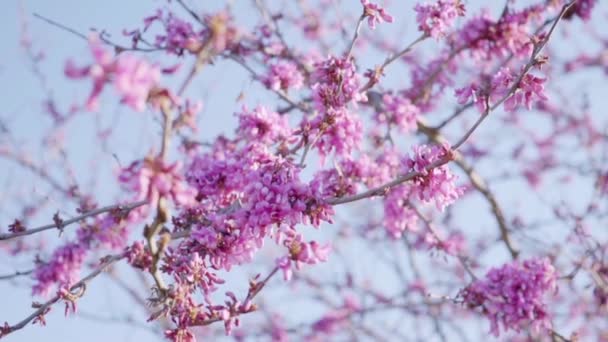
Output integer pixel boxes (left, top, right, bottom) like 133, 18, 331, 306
414, 0, 465, 39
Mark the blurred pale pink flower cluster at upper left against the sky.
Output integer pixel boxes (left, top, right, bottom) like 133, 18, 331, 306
65, 37, 161, 112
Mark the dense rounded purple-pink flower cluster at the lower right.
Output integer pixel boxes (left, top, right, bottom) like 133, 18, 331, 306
462, 258, 557, 336
